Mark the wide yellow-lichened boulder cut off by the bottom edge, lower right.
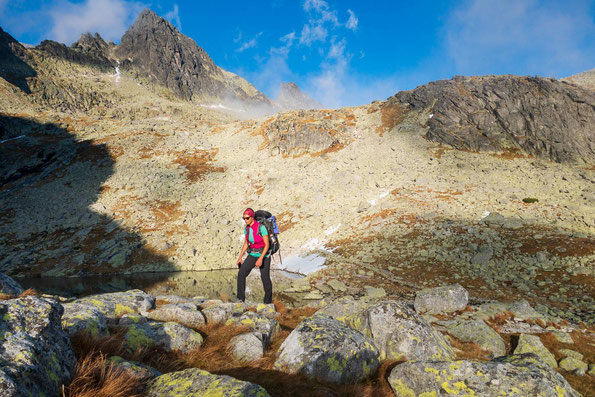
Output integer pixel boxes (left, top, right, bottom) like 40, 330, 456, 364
388, 354, 579, 397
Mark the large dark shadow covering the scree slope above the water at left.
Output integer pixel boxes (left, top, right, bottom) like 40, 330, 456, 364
0, 115, 176, 292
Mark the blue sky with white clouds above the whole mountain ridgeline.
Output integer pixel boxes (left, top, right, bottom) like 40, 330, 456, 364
0, 0, 595, 107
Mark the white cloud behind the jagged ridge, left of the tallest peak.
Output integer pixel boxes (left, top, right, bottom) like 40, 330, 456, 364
48, 0, 143, 44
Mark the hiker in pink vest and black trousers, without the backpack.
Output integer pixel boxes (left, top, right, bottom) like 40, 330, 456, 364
237, 208, 273, 303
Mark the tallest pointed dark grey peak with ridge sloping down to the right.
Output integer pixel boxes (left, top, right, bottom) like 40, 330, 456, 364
115, 10, 271, 106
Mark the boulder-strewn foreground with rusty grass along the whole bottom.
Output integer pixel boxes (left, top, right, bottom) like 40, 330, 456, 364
0, 273, 595, 397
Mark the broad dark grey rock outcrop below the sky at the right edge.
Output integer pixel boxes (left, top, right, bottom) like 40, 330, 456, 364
390, 75, 595, 164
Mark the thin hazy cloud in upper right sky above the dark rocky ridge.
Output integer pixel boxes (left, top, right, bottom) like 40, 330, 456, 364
445, 0, 595, 77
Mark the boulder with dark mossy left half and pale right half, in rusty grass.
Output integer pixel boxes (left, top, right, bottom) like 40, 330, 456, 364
124, 321, 203, 354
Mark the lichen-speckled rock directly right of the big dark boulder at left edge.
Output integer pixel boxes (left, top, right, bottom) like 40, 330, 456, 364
62, 302, 109, 338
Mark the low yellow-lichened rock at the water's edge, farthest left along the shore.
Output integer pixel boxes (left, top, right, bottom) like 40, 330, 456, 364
75, 289, 155, 321
